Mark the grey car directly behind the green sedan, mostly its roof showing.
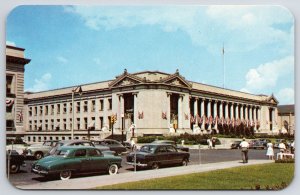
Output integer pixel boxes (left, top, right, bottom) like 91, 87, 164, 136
47, 139, 115, 155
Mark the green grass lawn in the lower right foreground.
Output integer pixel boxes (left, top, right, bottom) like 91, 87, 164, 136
97, 163, 295, 190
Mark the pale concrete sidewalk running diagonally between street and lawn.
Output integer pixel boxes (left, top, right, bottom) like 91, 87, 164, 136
16, 160, 273, 189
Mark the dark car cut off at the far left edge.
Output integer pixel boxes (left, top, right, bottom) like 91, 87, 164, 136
6, 150, 26, 173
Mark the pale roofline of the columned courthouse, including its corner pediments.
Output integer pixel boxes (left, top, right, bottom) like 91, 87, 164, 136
25, 69, 277, 103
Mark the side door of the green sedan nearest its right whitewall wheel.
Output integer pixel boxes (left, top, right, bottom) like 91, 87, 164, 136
87, 148, 108, 171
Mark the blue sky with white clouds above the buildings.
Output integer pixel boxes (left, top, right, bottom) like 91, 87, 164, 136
6, 5, 295, 105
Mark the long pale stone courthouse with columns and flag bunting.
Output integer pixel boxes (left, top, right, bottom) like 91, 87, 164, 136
7, 46, 279, 142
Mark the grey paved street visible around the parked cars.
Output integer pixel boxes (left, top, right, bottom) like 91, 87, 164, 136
10, 149, 277, 186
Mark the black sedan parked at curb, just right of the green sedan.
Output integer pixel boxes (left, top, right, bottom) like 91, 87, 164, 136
126, 143, 190, 169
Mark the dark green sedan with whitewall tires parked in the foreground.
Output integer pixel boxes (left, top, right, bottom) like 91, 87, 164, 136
31, 146, 122, 180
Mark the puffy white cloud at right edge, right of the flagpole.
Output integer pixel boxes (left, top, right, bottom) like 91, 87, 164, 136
245, 56, 294, 92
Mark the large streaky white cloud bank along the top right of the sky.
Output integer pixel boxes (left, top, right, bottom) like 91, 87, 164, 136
65, 6, 294, 52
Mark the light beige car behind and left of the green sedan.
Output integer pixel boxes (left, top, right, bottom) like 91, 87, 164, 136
24, 140, 58, 160
